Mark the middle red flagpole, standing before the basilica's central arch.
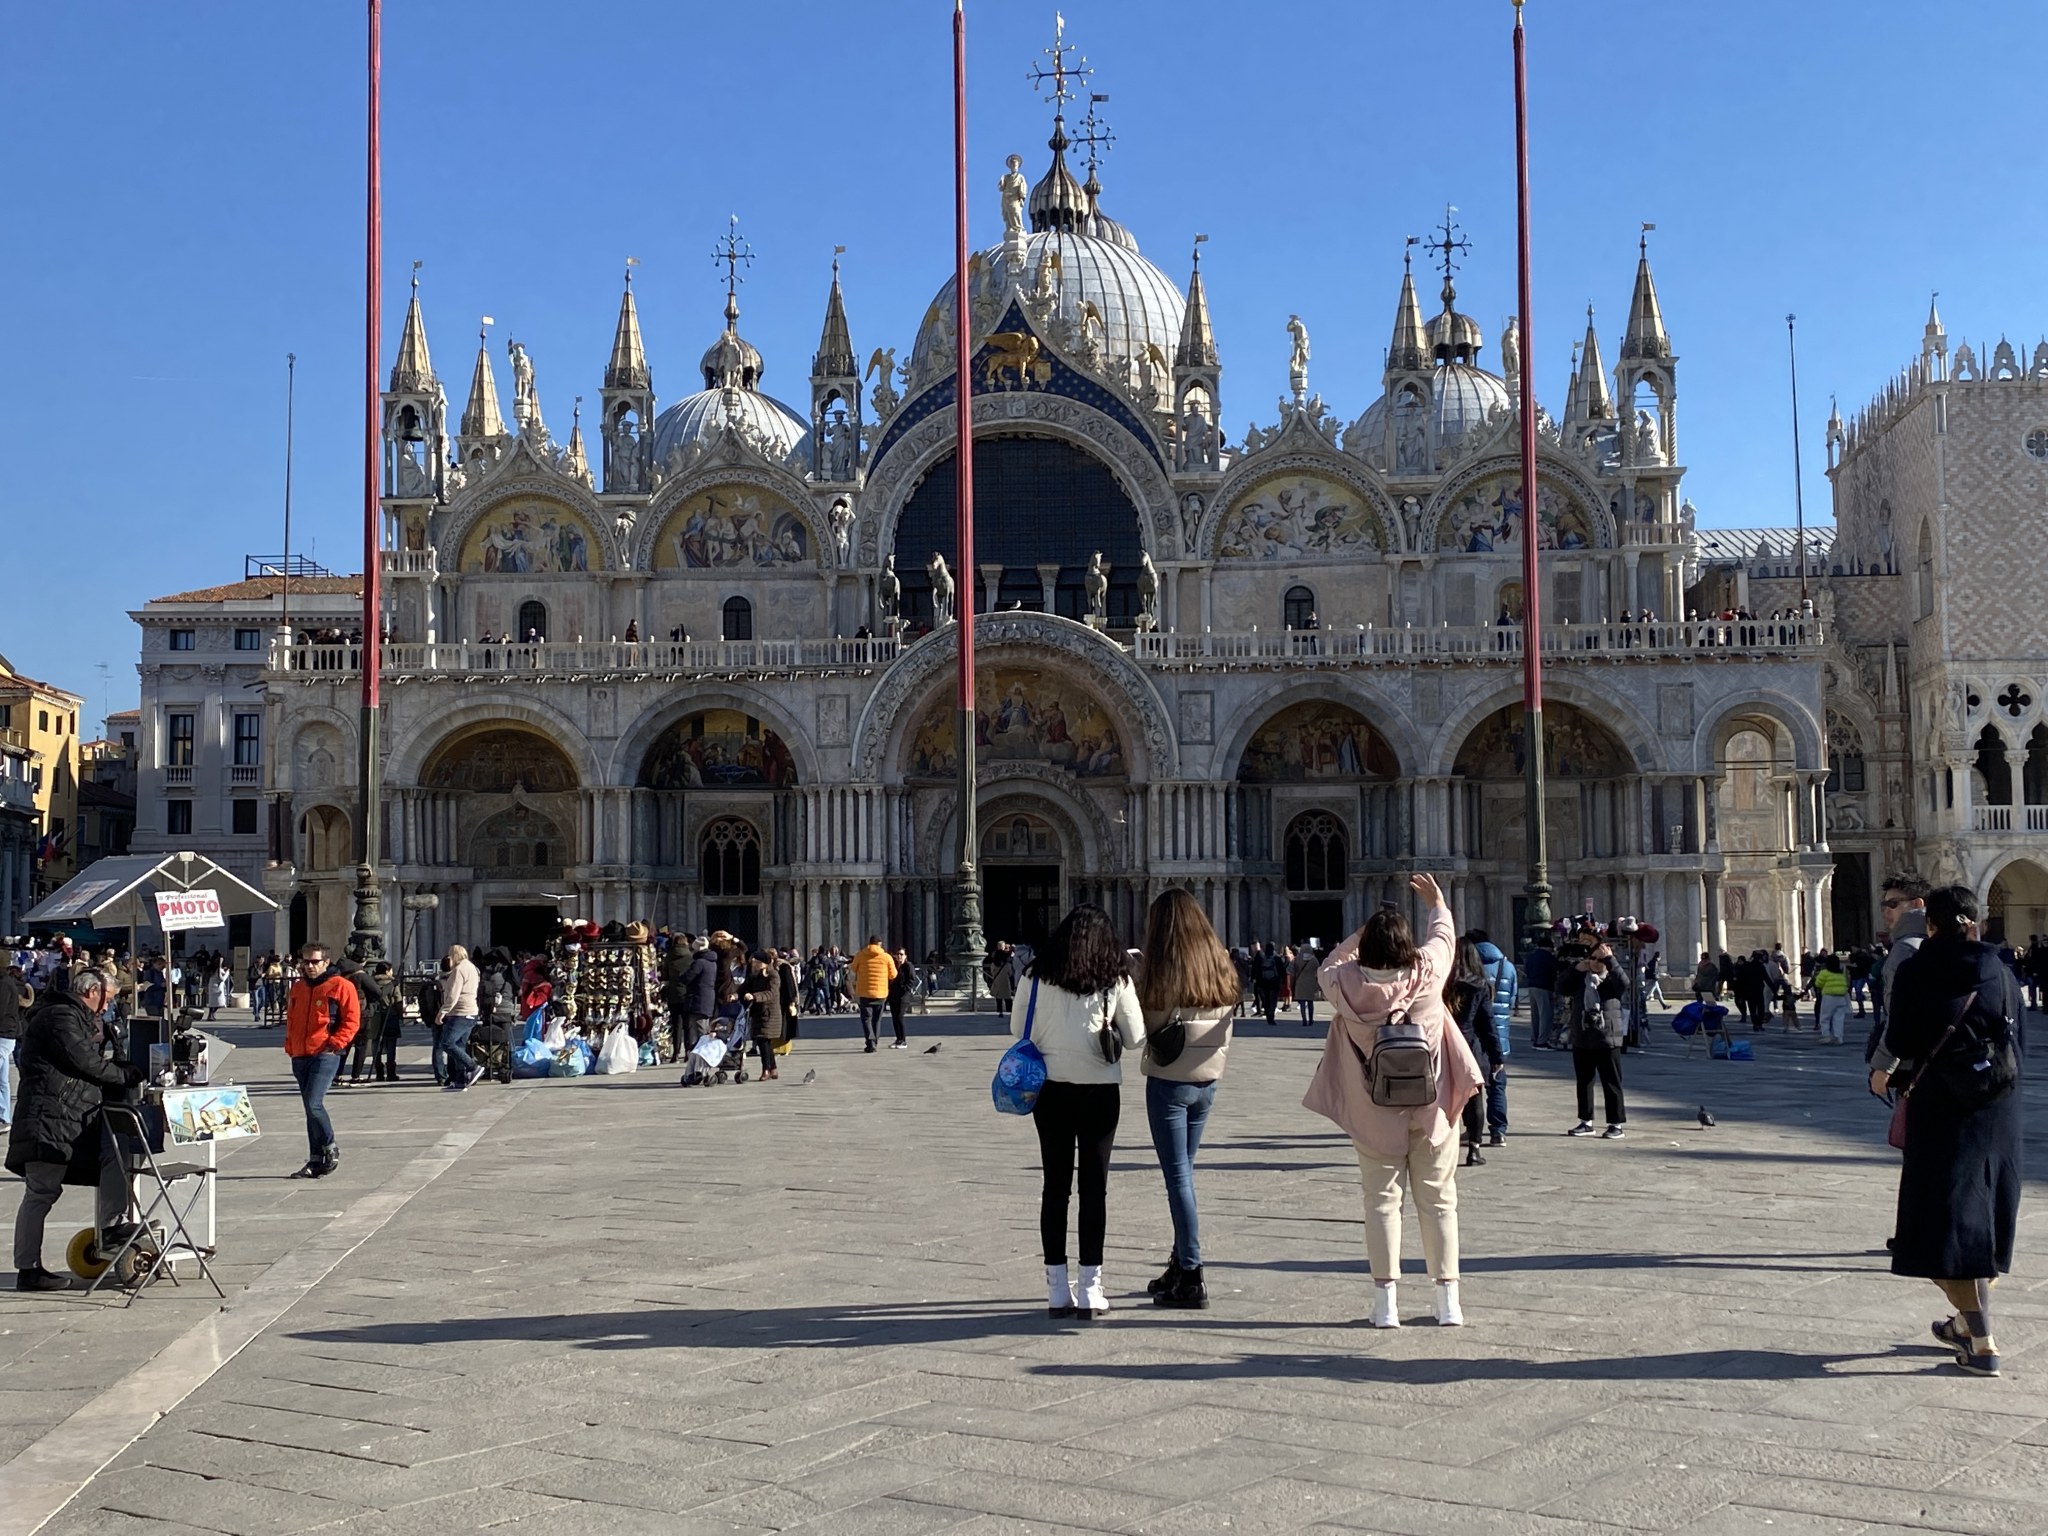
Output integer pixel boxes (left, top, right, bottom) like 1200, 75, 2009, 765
946, 0, 987, 997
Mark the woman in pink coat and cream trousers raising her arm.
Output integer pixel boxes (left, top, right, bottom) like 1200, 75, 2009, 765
1303, 874, 1483, 1327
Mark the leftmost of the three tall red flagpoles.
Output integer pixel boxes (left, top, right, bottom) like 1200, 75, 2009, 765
348, 0, 383, 961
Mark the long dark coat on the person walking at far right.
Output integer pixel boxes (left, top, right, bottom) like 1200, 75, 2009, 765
1884, 936, 2023, 1280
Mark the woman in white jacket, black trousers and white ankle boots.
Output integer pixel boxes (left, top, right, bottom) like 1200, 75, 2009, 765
1010, 905, 1145, 1321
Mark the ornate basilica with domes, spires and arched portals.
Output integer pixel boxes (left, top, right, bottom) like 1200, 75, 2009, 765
266, 81, 1843, 954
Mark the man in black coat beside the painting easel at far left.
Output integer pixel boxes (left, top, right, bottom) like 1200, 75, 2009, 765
6, 971, 143, 1290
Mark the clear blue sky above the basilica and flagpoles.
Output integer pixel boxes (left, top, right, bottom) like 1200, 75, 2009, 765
0, 0, 2048, 713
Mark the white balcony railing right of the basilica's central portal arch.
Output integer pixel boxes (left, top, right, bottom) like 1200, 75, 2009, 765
1133, 618, 1821, 666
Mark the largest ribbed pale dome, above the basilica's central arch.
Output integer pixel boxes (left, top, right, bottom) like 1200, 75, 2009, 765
911, 227, 1186, 375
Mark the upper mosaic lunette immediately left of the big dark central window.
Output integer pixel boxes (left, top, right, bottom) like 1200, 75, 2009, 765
633, 463, 825, 571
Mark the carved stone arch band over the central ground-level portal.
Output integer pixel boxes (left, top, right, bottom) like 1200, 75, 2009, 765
854, 612, 1180, 782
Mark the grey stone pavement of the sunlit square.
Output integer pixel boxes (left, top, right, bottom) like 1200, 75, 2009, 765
0, 999, 2048, 1536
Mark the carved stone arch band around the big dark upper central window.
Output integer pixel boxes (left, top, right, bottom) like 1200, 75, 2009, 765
854, 393, 1182, 567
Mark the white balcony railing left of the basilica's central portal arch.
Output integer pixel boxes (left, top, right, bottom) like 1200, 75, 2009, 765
270, 639, 901, 678
